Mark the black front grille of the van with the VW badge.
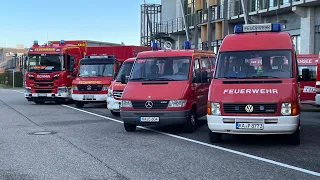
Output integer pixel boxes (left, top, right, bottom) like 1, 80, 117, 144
223, 103, 277, 114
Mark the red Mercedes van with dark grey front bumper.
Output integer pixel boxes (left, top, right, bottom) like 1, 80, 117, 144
120, 42, 215, 133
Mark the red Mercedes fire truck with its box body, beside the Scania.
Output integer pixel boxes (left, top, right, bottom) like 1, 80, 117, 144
72, 46, 151, 108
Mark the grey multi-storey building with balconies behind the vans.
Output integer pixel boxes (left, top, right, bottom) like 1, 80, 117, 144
156, 0, 320, 54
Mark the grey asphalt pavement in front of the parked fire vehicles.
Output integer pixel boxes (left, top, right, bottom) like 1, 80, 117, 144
0, 89, 320, 180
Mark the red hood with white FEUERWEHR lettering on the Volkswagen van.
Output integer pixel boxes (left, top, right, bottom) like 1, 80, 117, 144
208, 80, 297, 102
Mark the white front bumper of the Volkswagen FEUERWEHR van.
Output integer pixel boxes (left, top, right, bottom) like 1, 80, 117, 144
207, 115, 300, 134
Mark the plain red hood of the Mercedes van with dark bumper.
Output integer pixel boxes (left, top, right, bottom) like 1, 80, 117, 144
122, 81, 188, 100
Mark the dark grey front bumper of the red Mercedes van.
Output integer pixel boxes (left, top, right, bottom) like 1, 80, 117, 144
120, 110, 190, 126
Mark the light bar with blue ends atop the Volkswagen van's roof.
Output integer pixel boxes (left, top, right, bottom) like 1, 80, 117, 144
234, 23, 281, 34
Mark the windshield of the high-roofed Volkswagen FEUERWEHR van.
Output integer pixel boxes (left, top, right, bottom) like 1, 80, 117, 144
215, 50, 292, 79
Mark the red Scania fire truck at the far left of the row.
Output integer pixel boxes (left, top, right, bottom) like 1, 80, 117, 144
25, 40, 85, 103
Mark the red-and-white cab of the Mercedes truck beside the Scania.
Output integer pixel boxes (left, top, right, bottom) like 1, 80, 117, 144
72, 55, 118, 108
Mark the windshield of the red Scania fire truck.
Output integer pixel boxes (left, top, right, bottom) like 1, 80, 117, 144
27, 54, 64, 72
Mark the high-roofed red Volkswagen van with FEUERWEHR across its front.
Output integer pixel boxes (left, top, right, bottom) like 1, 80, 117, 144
207, 23, 305, 144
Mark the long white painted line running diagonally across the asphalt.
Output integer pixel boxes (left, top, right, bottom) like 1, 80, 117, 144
62, 105, 320, 177
